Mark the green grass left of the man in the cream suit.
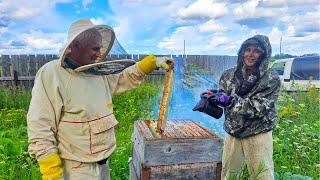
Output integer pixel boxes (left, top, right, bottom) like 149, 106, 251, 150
0, 88, 40, 179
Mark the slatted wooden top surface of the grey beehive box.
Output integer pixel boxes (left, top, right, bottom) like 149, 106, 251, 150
136, 120, 221, 140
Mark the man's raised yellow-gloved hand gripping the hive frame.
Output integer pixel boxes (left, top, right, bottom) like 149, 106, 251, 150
138, 55, 173, 74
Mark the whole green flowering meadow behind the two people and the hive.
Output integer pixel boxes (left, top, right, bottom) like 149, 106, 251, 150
0, 83, 320, 180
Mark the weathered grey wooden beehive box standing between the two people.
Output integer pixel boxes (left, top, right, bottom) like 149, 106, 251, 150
130, 120, 223, 180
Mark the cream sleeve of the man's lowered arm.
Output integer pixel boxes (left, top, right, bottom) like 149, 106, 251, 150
27, 67, 63, 159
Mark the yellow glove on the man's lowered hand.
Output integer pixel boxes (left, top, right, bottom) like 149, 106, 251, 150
38, 153, 63, 180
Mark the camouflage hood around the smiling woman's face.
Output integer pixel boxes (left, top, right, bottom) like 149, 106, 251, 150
237, 35, 272, 76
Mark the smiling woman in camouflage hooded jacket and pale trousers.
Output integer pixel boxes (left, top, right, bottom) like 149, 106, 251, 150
209, 35, 280, 180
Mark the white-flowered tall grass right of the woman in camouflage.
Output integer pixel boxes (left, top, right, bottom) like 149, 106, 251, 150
273, 88, 320, 179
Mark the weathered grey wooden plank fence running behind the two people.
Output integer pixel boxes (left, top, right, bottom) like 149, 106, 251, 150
0, 54, 236, 88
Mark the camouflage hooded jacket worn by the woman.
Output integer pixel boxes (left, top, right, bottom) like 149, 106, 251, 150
220, 35, 280, 138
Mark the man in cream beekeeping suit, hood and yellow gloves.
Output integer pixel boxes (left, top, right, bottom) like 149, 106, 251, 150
27, 20, 171, 180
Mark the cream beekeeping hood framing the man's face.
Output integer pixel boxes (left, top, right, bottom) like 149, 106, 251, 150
59, 19, 115, 66
